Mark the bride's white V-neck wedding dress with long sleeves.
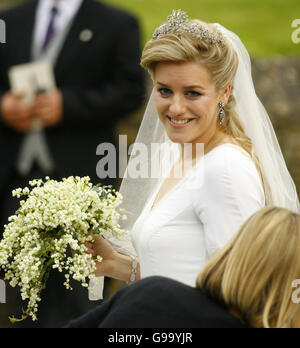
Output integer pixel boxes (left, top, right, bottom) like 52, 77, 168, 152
131, 143, 265, 286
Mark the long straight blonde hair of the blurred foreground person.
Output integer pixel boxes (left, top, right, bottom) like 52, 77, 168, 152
196, 207, 300, 328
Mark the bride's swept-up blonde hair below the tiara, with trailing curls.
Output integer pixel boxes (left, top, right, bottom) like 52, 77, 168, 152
141, 19, 264, 193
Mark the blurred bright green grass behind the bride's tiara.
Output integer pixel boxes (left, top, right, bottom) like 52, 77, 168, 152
0, 0, 300, 57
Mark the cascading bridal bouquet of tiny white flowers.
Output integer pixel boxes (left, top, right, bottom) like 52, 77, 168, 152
0, 177, 126, 322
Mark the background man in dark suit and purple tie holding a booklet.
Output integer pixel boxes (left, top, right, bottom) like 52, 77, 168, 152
0, 0, 145, 326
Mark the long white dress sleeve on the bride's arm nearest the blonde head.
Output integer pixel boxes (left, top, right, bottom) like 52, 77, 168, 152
194, 146, 264, 258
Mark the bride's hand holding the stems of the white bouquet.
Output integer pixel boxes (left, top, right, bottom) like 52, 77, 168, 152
85, 235, 118, 277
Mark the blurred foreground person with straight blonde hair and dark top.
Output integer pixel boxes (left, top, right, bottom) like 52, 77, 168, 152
70, 207, 300, 328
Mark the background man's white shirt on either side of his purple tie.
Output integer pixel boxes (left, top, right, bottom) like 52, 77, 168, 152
34, 0, 83, 47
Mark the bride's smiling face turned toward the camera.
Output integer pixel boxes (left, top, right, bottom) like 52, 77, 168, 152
154, 62, 226, 144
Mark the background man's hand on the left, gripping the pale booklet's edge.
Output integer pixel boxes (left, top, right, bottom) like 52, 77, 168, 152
0, 92, 34, 132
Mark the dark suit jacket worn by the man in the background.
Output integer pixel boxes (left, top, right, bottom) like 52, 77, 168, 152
0, 0, 145, 185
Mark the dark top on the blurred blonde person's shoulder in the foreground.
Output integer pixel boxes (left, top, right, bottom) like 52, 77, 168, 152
66, 277, 243, 328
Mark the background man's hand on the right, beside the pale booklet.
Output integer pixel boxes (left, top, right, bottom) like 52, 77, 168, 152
34, 90, 63, 127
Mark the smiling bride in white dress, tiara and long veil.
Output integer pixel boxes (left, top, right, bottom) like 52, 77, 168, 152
87, 10, 299, 299
